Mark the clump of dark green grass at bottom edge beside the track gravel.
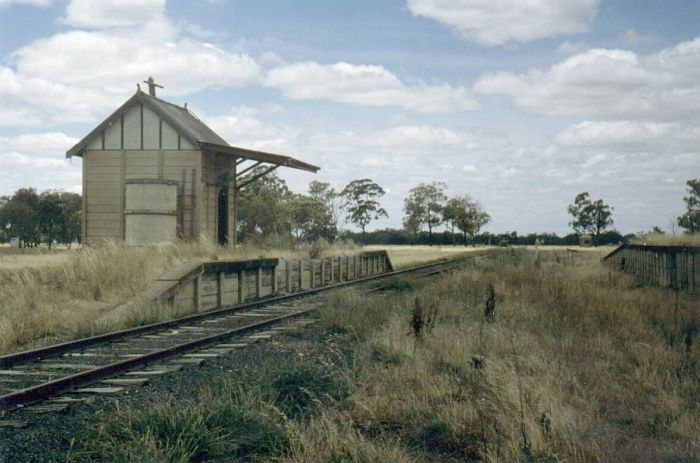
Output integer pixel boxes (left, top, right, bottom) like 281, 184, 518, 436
72, 384, 289, 463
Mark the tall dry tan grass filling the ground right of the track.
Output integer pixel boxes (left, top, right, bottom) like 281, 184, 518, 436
323, 254, 700, 462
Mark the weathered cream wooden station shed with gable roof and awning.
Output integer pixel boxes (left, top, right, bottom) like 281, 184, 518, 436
66, 78, 319, 245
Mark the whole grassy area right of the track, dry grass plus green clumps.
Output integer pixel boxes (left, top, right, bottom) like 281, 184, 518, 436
74, 252, 700, 463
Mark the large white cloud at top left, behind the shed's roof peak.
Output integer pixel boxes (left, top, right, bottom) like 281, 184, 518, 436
0, 0, 260, 127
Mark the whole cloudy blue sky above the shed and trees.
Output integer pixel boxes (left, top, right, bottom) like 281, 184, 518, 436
0, 0, 700, 234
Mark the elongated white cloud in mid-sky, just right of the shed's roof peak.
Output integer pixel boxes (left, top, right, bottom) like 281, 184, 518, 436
265, 62, 478, 113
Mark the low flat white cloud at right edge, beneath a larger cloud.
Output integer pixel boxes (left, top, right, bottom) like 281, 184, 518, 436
555, 121, 700, 153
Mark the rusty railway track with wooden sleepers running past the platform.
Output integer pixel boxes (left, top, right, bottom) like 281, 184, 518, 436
0, 252, 504, 413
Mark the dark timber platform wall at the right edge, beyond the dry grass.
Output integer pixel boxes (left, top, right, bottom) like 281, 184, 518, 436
603, 244, 700, 293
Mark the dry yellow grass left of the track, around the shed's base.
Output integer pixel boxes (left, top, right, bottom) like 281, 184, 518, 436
0, 242, 354, 353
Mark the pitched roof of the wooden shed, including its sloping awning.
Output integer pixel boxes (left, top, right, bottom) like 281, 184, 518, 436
66, 89, 319, 172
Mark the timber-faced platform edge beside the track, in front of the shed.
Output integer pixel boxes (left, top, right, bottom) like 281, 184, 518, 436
142, 251, 393, 312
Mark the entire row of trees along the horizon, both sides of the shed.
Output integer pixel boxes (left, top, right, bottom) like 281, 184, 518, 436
0, 175, 700, 247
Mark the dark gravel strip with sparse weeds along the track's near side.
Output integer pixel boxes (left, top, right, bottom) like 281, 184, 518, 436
0, 323, 349, 463
